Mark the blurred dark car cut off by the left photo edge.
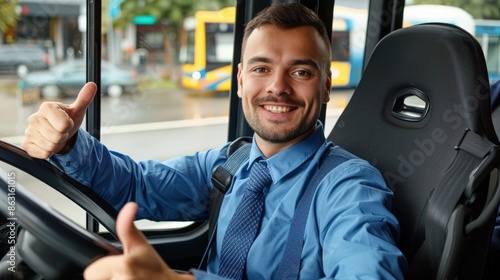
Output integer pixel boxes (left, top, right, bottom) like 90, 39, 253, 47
0, 44, 50, 77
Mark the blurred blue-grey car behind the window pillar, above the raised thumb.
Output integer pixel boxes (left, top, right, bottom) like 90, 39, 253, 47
19, 59, 137, 99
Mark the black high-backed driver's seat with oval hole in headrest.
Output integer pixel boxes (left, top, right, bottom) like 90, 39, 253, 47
328, 23, 500, 279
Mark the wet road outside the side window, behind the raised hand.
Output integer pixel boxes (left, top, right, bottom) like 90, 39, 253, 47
0, 76, 229, 137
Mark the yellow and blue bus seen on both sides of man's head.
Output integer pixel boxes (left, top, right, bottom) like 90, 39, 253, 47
180, 6, 367, 92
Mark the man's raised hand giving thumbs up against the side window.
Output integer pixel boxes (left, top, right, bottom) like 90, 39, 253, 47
22, 82, 97, 159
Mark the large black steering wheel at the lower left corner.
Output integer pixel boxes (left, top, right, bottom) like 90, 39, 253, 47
0, 140, 122, 279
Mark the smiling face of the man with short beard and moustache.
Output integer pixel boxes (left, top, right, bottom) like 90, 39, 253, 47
238, 25, 331, 147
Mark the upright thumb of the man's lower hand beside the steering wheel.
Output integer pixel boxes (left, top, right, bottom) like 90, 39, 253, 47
116, 202, 149, 254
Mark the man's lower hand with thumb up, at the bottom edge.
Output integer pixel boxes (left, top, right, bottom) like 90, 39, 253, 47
84, 202, 194, 280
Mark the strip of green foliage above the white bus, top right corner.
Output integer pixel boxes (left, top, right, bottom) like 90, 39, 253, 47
414, 0, 500, 19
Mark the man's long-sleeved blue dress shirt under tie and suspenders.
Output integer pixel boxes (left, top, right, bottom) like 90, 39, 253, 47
50, 122, 407, 280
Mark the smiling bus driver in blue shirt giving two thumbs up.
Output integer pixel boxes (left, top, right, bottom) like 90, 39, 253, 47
23, 4, 406, 279
